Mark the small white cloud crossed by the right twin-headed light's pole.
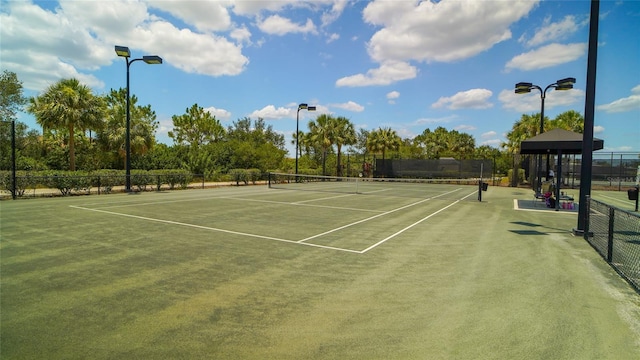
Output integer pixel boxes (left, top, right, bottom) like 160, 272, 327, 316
498, 89, 585, 113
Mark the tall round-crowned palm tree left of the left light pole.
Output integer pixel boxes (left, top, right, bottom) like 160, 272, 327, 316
27, 78, 105, 171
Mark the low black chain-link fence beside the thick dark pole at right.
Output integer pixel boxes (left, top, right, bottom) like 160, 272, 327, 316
585, 198, 640, 291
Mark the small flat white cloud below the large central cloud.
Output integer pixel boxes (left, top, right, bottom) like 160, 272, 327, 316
336, 61, 418, 87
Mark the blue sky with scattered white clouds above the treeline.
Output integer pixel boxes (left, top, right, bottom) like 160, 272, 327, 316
0, 0, 640, 155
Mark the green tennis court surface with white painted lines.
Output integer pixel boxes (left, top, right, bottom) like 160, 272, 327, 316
0, 183, 640, 359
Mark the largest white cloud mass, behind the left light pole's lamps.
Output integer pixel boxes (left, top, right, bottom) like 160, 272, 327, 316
0, 0, 249, 91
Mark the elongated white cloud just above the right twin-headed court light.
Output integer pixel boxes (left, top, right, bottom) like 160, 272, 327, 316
505, 43, 587, 71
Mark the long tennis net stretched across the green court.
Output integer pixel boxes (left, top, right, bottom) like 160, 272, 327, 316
269, 173, 480, 199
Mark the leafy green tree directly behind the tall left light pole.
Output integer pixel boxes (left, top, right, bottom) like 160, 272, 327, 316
97, 88, 158, 168
